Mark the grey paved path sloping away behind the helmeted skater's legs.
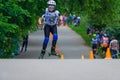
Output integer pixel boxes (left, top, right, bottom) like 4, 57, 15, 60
15, 27, 90, 59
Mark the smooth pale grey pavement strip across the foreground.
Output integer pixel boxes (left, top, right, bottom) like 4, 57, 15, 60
0, 59, 120, 80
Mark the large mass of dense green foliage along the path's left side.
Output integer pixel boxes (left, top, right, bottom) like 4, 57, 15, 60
0, 0, 32, 57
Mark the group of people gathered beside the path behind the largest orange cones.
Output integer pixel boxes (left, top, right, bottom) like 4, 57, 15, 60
87, 26, 119, 59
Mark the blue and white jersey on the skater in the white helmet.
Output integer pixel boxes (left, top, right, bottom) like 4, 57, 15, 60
42, 8, 60, 26
